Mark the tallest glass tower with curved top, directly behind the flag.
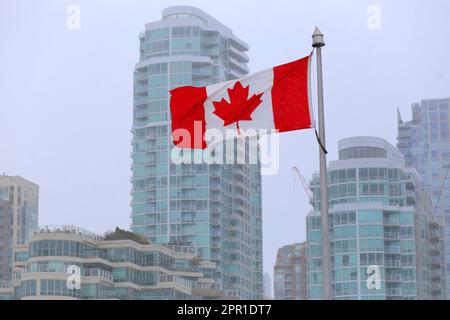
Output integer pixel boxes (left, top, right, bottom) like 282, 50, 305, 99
131, 6, 263, 299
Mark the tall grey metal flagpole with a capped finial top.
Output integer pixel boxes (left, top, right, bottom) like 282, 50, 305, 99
312, 27, 331, 300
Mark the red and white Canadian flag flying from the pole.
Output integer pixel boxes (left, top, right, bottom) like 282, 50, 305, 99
170, 56, 314, 149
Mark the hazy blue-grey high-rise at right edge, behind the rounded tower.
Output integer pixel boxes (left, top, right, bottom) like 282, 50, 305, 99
397, 98, 450, 298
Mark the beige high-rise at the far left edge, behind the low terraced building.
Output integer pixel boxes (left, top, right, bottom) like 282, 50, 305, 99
0, 175, 39, 287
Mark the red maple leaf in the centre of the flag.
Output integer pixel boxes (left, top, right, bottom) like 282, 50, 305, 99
213, 81, 263, 134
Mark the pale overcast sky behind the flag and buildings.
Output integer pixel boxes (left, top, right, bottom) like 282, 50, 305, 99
0, 0, 450, 290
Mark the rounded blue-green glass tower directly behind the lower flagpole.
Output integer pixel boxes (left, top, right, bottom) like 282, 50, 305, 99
307, 137, 446, 300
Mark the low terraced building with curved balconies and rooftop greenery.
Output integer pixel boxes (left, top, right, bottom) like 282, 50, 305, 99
13, 226, 224, 300
